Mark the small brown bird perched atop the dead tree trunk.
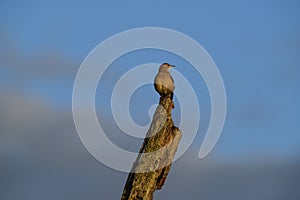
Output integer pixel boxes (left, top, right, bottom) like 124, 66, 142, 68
154, 63, 175, 100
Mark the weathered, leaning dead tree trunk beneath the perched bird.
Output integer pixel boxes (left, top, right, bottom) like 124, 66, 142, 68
121, 97, 181, 200
